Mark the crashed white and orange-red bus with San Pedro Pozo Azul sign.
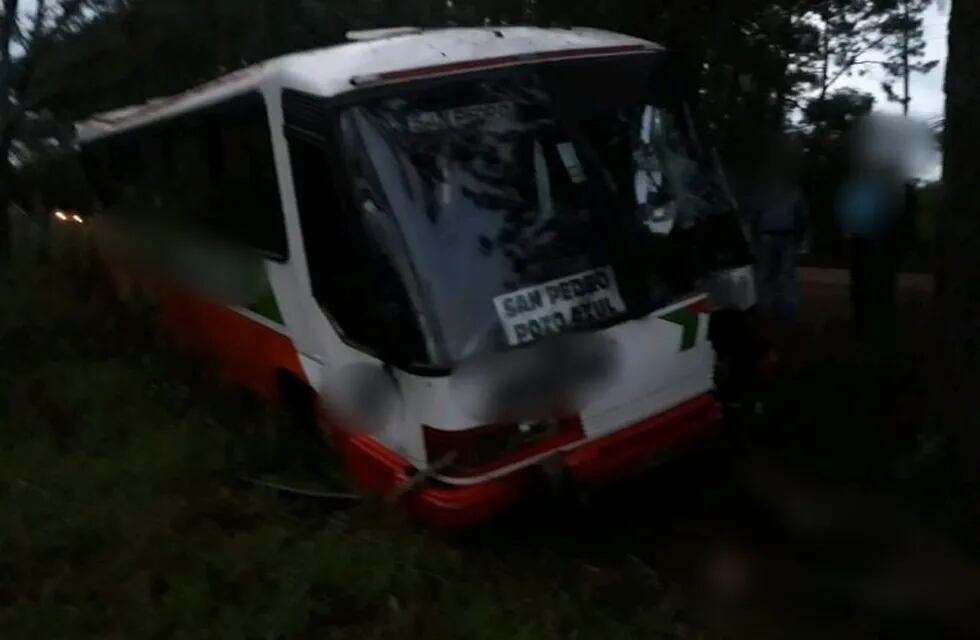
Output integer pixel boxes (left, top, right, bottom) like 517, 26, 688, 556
79, 27, 748, 527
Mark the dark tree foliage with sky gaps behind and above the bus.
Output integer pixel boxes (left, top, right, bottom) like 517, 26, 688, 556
0, 0, 935, 260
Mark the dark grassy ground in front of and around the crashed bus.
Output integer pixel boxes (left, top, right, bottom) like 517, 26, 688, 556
0, 242, 980, 640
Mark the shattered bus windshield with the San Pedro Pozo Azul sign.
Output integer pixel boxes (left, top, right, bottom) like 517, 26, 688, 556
330, 56, 731, 366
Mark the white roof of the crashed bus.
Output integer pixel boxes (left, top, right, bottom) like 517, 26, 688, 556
77, 27, 659, 144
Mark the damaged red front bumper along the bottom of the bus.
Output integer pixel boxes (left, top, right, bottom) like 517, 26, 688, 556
337, 395, 720, 530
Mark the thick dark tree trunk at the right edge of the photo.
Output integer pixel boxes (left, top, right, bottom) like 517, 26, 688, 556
935, 0, 980, 481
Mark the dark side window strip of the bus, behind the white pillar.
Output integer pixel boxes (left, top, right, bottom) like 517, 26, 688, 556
83, 93, 289, 260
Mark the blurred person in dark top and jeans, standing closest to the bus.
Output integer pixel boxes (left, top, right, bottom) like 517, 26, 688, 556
747, 153, 807, 320
